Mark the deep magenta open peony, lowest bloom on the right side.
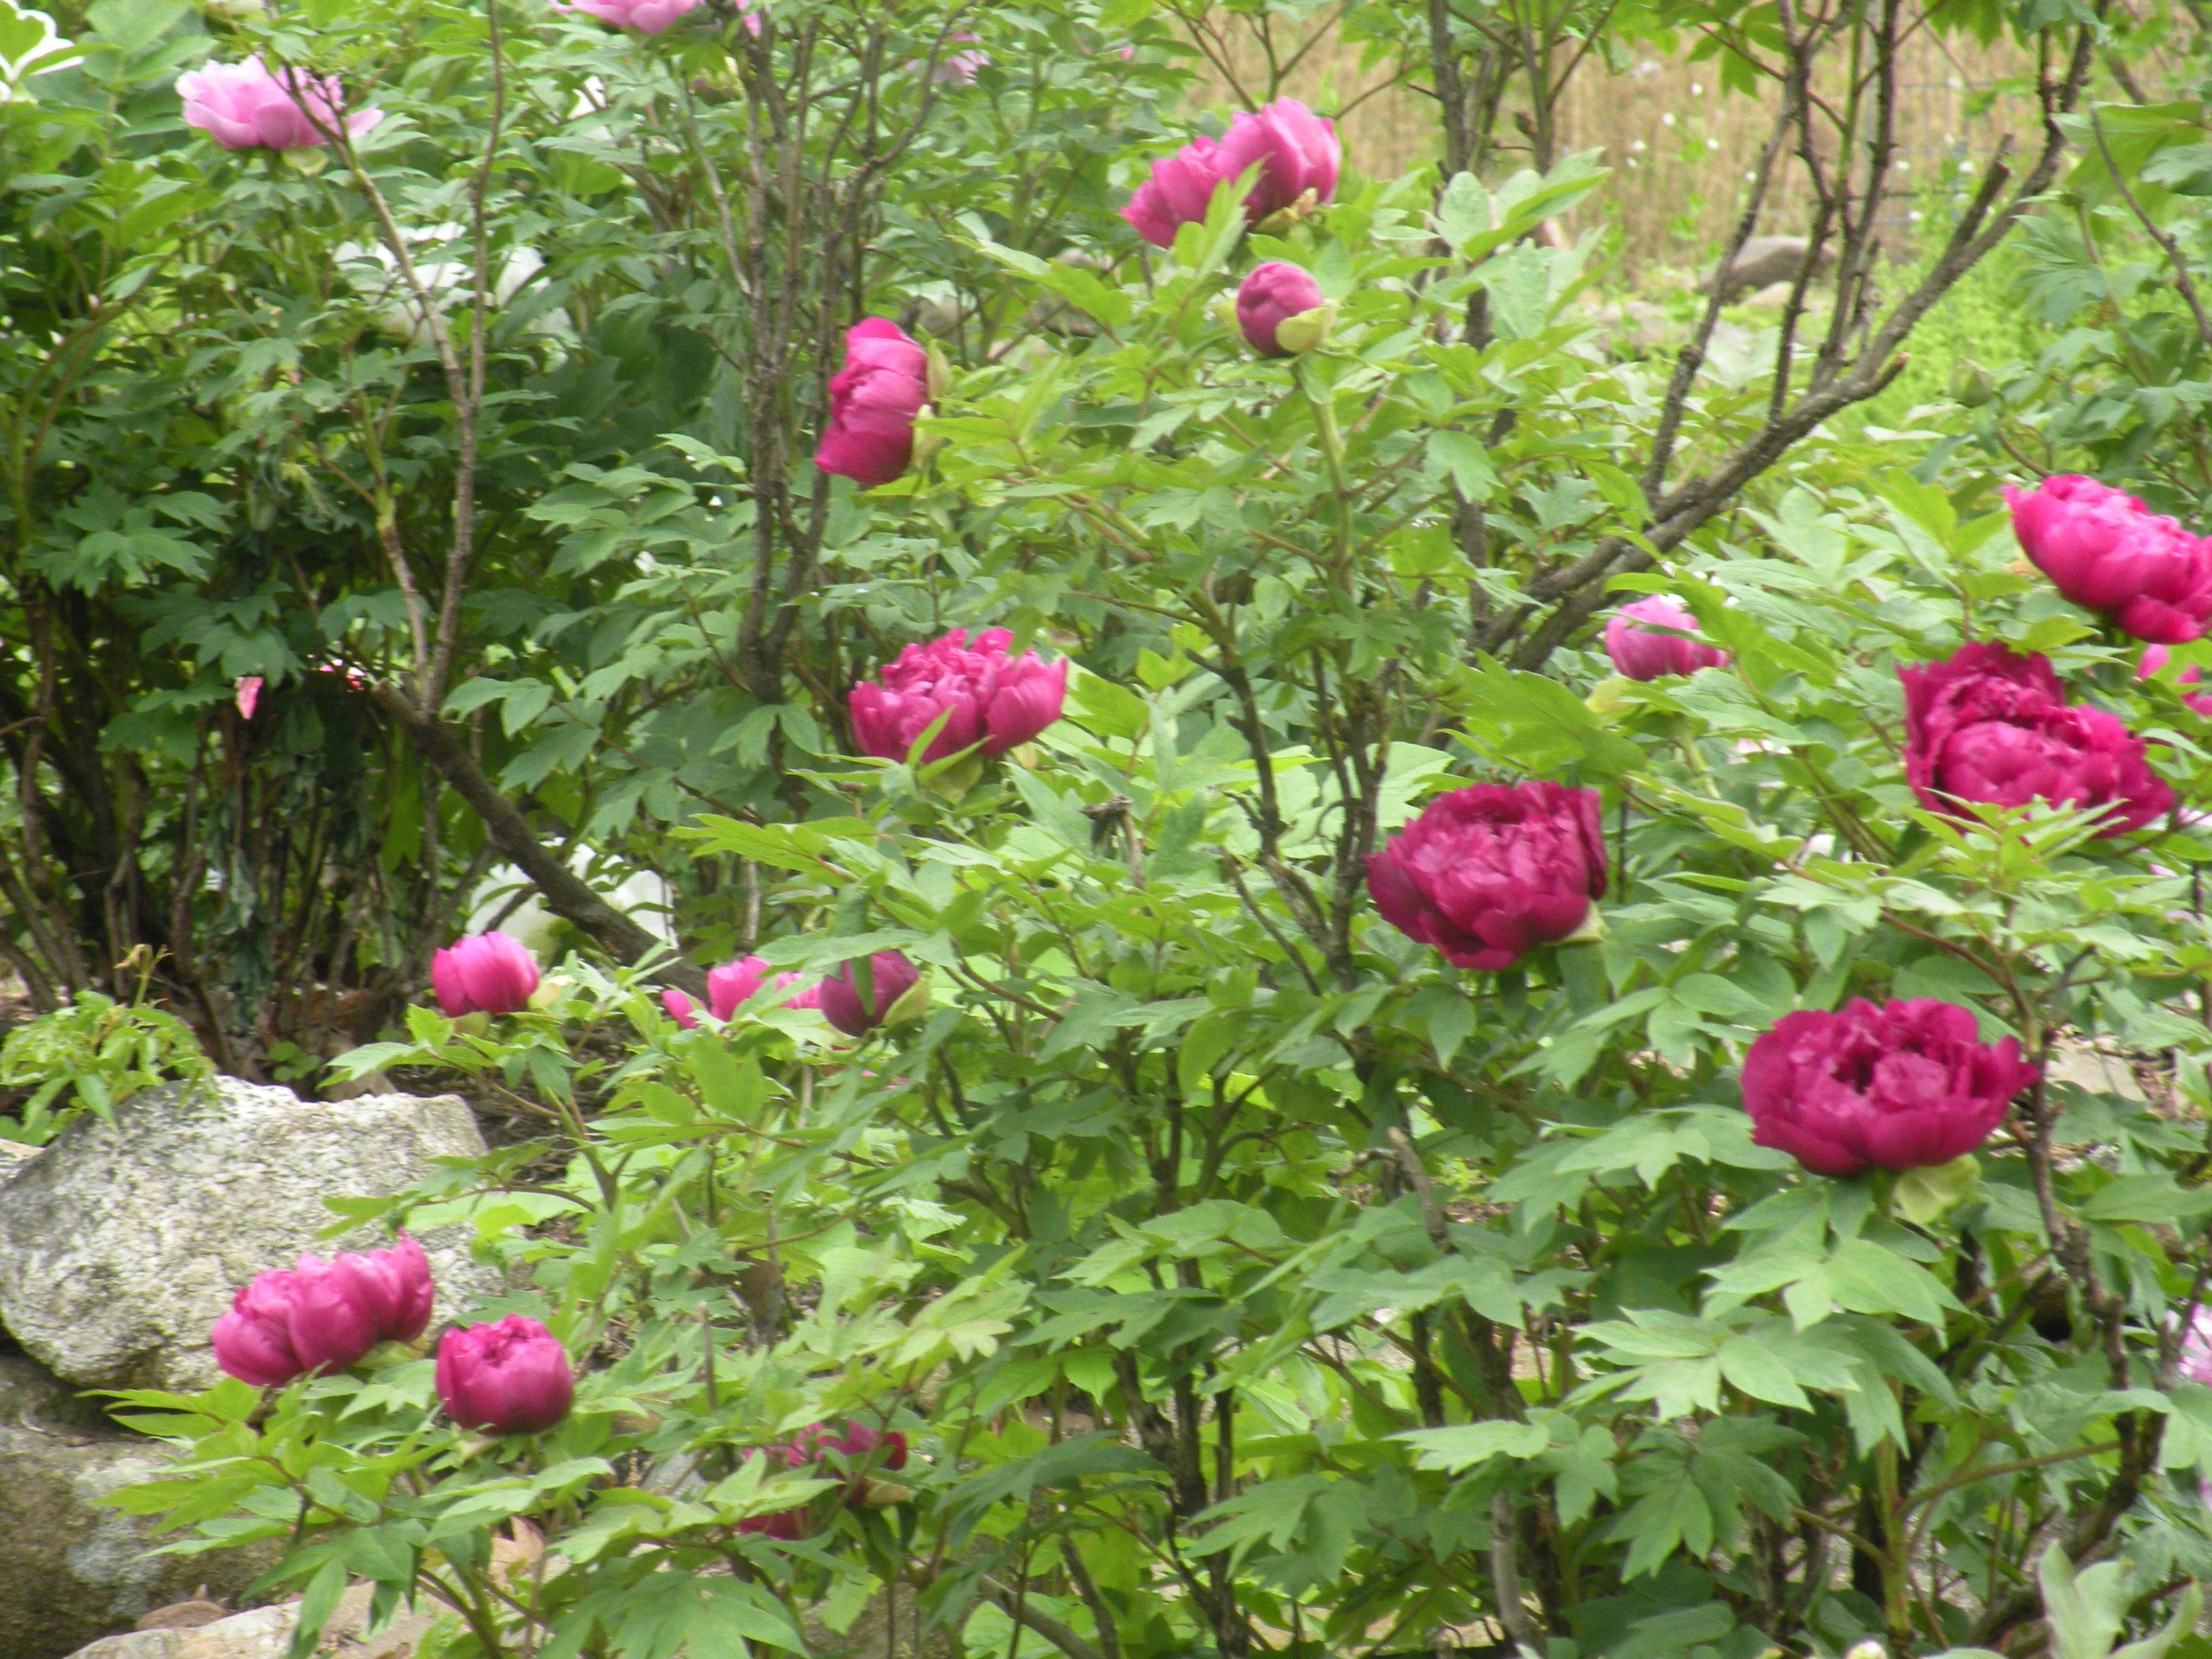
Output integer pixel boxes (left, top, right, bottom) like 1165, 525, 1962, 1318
1743, 997, 2037, 1175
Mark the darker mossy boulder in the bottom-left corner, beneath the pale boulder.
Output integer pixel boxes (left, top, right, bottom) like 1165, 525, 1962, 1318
0, 1352, 274, 1659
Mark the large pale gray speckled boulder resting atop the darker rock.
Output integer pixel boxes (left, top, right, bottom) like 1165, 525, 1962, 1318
0, 1078, 500, 1398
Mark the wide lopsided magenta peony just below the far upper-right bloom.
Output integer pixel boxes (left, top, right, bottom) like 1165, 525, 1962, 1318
1898, 644, 2174, 836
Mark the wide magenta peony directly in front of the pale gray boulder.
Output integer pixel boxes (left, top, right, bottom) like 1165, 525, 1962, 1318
208, 1235, 434, 1387
